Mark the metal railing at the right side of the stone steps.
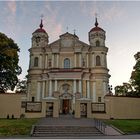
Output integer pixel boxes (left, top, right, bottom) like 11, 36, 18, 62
94, 119, 106, 135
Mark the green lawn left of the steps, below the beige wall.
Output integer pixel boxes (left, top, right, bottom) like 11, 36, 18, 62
0, 119, 38, 136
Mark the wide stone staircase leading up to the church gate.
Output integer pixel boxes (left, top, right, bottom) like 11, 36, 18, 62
31, 125, 103, 138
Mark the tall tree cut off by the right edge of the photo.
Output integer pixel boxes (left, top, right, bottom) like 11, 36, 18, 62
130, 52, 140, 96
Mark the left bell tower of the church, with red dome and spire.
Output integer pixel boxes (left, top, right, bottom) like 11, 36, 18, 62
27, 19, 49, 101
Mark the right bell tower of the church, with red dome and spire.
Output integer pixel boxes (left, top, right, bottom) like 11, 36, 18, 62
89, 17, 110, 102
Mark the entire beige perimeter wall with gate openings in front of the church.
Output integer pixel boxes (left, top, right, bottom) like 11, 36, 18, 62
0, 93, 140, 119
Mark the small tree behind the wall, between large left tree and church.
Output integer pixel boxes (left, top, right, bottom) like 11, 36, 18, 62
16, 79, 27, 93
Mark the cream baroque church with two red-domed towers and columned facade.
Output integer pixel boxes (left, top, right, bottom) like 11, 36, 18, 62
27, 18, 110, 117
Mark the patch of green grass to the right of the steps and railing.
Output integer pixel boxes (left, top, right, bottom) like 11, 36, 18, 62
105, 120, 140, 134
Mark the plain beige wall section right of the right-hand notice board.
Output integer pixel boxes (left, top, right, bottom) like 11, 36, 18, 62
105, 96, 140, 119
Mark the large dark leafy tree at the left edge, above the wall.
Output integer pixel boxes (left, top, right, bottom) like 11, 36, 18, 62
0, 33, 21, 92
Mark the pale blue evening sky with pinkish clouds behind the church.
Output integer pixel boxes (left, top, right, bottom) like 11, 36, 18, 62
0, 0, 140, 93
